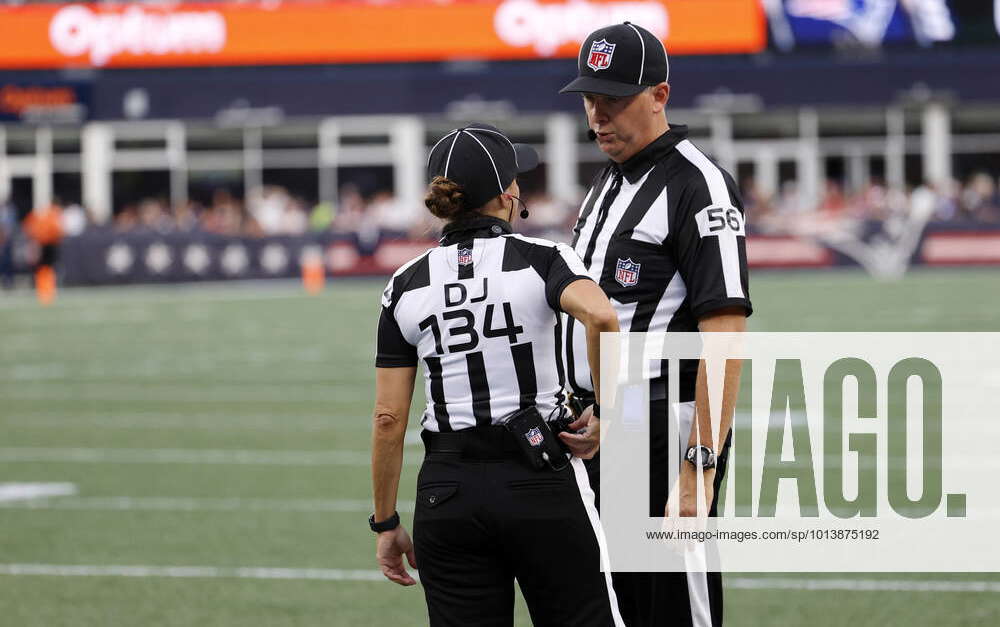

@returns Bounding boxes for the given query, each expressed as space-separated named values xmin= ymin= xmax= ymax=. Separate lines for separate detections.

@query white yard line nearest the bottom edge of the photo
xmin=0 ymin=564 xmax=1000 ymax=593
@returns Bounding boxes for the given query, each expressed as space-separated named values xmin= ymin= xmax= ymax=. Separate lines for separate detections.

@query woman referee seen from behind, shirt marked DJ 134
xmin=369 ymin=124 xmax=623 ymax=627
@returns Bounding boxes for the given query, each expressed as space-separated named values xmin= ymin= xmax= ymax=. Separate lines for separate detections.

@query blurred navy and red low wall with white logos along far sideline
xmin=60 ymin=230 xmax=1000 ymax=285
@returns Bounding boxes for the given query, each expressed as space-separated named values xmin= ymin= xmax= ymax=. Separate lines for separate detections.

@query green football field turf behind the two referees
xmin=0 ymin=270 xmax=1000 ymax=627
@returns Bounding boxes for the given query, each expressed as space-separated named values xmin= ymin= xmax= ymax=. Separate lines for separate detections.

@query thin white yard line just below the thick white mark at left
xmin=0 ymin=496 xmax=414 ymax=513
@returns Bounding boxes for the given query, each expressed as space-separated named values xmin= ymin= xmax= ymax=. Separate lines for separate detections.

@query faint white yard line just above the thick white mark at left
xmin=0 ymin=447 xmax=421 ymax=466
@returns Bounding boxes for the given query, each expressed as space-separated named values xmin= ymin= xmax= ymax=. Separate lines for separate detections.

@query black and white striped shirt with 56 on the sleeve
xmin=565 ymin=126 xmax=752 ymax=402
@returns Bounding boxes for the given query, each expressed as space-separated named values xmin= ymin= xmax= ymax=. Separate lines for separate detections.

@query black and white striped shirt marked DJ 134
xmin=375 ymin=217 xmax=589 ymax=431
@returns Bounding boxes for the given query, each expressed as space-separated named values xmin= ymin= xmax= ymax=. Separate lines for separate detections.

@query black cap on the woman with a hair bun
xmin=427 ymin=122 xmax=538 ymax=209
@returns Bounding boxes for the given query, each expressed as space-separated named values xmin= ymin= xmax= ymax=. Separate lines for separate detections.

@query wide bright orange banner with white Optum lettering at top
xmin=0 ymin=0 xmax=767 ymax=69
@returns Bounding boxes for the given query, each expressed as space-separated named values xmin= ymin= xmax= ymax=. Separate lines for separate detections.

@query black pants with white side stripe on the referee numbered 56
xmin=584 ymin=401 xmax=731 ymax=627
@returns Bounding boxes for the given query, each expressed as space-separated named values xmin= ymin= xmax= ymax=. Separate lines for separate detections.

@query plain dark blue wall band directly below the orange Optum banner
xmin=0 ymin=49 xmax=1000 ymax=119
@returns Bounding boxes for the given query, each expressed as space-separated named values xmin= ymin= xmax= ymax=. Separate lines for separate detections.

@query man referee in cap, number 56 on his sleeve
xmin=562 ymin=22 xmax=752 ymax=627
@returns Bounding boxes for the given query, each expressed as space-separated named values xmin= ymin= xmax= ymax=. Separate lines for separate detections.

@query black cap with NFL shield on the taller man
xmin=559 ymin=22 xmax=670 ymax=97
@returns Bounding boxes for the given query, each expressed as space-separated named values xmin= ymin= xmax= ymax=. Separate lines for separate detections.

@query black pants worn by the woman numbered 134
xmin=413 ymin=427 xmax=621 ymax=627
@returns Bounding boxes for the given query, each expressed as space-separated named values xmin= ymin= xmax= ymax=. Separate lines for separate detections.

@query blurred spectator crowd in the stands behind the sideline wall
xmin=0 ymin=173 xmax=1000 ymax=252
